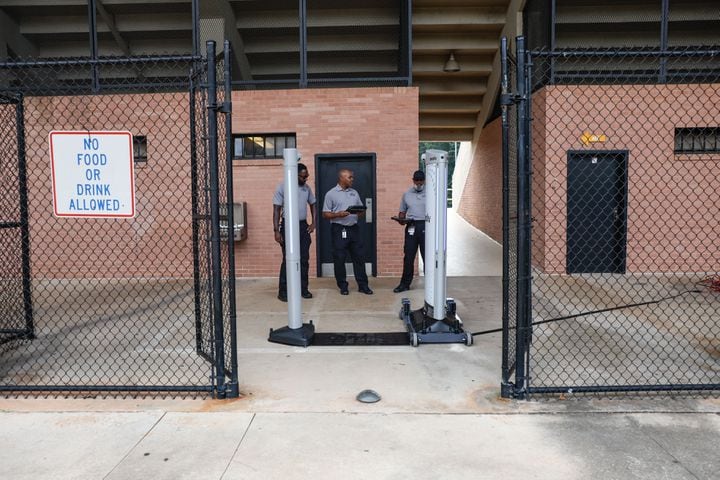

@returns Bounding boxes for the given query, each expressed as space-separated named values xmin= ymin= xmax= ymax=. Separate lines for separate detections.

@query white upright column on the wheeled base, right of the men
xmin=425 ymin=150 xmax=448 ymax=320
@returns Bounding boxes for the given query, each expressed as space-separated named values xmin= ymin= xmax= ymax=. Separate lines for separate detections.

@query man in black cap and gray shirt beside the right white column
xmin=393 ymin=170 xmax=425 ymax=293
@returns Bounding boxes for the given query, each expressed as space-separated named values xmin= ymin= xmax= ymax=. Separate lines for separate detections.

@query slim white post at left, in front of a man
xmin=283 ymin=148 xmax=302 ymax=330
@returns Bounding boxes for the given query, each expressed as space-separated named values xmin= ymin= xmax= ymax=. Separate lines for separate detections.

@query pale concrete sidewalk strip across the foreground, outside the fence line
xmin=0 ymin=401 xmax=720 ymax=480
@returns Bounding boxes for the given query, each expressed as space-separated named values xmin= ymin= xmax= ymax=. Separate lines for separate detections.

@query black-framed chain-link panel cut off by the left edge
xmin=0 ymin=96 xmax=34 ymax=343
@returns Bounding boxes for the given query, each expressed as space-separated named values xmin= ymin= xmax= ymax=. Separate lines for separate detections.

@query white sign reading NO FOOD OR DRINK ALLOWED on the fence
xmin=50 ymin=131 xmax=135 ymax=218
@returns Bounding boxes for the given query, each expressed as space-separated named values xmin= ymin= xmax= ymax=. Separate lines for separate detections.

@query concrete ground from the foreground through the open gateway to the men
xmin=0 ymin=209 xmax=720 ymax=480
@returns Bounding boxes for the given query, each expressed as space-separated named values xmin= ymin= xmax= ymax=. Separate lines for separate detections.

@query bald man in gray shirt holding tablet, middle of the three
xmin=323 ymin=168 xmax=373 ymax=295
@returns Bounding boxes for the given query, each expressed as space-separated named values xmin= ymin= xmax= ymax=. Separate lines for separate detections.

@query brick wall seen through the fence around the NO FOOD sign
xmin=22 ymin=93 xmax=193 ymax=278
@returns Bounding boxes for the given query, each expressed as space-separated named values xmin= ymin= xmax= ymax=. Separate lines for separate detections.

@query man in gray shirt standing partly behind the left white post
xmin=273 ymin=163 xmax=316 ymax=302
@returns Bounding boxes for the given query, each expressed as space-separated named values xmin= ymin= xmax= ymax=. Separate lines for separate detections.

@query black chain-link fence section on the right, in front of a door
xmin=501 ymin=37 xmax=720 ymax=398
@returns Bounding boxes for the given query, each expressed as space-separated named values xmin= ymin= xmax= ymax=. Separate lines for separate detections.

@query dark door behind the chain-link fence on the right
xmin=567 ymin=151 xmax=628 ymax=273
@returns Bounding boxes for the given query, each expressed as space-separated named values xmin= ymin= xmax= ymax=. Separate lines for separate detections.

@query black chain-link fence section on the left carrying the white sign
xmin=0 ymin=42 xmax=238 ymax=398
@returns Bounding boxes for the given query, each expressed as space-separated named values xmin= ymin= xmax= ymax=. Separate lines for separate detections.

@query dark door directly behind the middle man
xmin=315 ymin=153 xmax=377 ymax=277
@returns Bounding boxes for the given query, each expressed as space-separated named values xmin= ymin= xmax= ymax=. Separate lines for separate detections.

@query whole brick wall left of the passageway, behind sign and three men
xmin=16 ymin=87 xmax=418 ymax=278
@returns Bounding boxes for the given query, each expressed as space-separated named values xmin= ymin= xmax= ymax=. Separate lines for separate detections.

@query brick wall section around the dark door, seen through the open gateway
xmin=232 ymin=87 xmax=418 ymax=276
